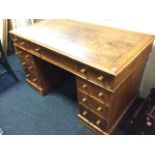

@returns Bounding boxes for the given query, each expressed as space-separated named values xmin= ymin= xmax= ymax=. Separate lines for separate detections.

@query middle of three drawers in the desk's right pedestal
xmin=78 ymin=91 xmax=110 ymax=119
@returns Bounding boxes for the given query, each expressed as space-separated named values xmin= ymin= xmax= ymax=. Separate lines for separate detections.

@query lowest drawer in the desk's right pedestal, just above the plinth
xmin=79 ymin=104 xmax=108 ymax=130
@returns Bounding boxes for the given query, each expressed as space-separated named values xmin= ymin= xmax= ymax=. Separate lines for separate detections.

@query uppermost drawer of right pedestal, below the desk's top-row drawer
xmin=77 ymin=78 xmax=110 ymax=105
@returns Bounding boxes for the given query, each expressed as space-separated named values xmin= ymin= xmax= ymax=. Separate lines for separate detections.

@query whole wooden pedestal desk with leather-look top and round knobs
xmin=11 ymin=20 xmax=154 ymax=134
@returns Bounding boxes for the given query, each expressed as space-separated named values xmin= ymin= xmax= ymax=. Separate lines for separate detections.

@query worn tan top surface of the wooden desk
xmin=11 ymin=19 xmax=154 ymax=76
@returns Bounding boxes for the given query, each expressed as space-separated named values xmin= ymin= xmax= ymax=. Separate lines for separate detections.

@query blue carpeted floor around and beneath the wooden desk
xmin=0 ymin=54 xmax=125 ymax=135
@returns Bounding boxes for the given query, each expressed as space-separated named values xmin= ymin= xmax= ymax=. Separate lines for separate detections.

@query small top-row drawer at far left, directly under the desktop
xmin=12 ymin=36 xmax=29 ymax=50
